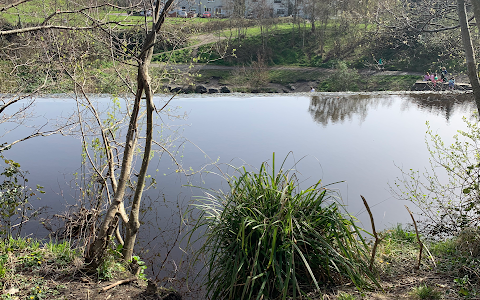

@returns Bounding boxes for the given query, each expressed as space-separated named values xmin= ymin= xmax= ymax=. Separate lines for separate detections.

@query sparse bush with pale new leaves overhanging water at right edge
xmin=392 ymin=116 xmax=480 ymax=236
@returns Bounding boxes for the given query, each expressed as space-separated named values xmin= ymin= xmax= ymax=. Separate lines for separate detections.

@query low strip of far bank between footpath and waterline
xmin=0 ymin=63 xmax=468 ymax=95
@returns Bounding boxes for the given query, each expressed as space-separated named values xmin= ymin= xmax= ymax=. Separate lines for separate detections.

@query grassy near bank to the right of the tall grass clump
xmin=331 ymin=225 xmax=480 ymax=300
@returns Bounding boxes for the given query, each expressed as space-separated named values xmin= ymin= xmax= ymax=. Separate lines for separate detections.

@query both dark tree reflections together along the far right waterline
xmin=308 ymin=93 xmax=475 ymax=126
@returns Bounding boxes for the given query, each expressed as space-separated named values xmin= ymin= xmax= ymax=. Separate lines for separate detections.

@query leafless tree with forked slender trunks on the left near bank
xmin=0 ymin=0 xmax=182 ymax=268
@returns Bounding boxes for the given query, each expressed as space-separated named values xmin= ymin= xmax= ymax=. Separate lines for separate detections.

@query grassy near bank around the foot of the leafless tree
xmin=0 ymin=238 xmax=183 ymax=300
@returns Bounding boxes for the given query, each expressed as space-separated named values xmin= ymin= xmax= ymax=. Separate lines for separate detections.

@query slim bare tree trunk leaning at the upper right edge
xmin=457 ymin=0 xmax=480 ymax=111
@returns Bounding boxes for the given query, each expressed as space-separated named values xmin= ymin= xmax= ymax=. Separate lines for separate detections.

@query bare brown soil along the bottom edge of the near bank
xmin=3 ymin=266 xmax=472 ymax=300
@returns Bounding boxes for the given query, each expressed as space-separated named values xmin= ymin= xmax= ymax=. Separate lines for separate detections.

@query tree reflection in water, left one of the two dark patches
xmin=308 ymin=95 xmax=392 ymax=126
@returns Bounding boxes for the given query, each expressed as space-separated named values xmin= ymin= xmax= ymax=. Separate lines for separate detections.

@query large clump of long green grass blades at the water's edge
xmin=195 ymin=158 xmax=376 ymax=299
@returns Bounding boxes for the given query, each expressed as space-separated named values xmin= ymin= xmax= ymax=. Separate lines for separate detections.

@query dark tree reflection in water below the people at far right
xmin=402 ymin=93 xmax=476 ymax=121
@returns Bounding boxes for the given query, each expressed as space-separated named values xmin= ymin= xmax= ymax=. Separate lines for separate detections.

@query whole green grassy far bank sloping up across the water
xmin=0 ymin=12 xmax=465 ymax=94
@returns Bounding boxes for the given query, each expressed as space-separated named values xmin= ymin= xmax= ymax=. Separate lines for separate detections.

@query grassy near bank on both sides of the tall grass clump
xmin=0 ymin=225 xmax=480 ymax=300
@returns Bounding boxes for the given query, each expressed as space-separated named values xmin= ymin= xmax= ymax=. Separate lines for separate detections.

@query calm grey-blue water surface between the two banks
xmin=3 ymin=94 xmax=474 ymax=276
